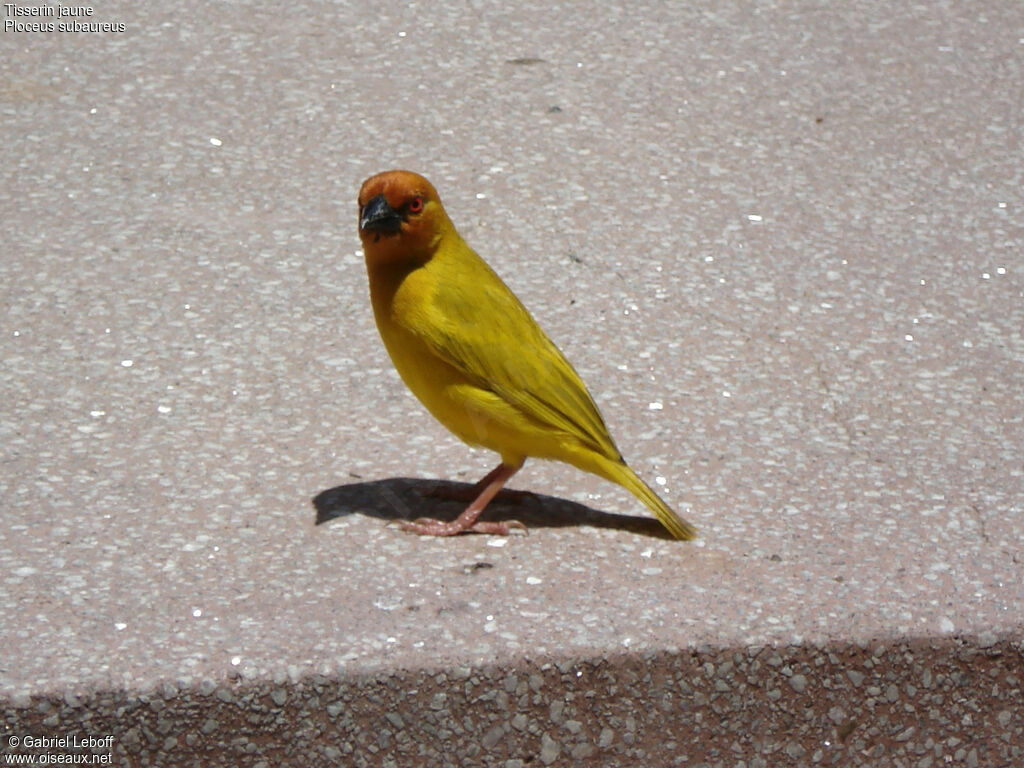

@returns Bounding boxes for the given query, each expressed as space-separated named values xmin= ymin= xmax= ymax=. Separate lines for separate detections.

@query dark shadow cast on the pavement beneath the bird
xmin=312 ymin=477 xmax=672 ymax=540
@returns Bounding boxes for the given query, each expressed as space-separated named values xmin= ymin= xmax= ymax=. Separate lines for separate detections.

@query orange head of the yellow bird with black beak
xmin=359 ymin=171 xmax=452 ymax=265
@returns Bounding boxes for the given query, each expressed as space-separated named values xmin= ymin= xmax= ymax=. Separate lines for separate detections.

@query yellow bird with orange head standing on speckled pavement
xmin=358 ymin=171 xmax=696 ymax=539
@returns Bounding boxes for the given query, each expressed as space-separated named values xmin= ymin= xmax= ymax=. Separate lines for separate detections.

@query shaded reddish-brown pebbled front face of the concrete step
xmin=8 ymin=640 xmax=1024 ymax=768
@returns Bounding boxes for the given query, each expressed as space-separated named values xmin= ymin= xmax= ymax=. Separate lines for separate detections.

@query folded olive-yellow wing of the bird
xmin=416 ymin=239 xmax=622 ymax=461
